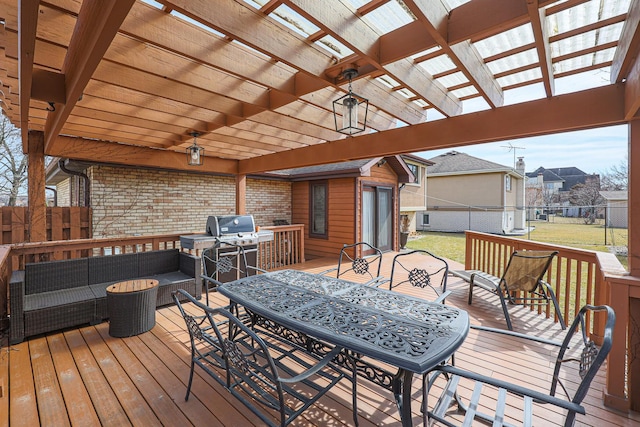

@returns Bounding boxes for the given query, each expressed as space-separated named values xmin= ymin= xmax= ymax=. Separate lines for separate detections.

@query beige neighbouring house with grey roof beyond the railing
xmin=422 ymin=151 xmax=525 ymax=234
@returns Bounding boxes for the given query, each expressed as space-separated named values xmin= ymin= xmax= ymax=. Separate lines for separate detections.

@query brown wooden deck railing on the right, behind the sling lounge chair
xmin=465 ymin=231 xmax=625 ymax=339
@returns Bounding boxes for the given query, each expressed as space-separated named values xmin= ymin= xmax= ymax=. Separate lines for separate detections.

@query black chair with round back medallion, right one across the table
xmin=389 ymin=249 xmax=451 ymax=303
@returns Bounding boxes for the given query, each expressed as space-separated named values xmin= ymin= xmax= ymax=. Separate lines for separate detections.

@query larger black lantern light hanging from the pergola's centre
xmin=333 ymin=68 xmax=369 ymax=135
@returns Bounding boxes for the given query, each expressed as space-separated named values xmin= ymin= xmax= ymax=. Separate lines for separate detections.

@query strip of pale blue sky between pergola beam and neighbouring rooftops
xmin=414 ymin=125 xmax=628 ymax=174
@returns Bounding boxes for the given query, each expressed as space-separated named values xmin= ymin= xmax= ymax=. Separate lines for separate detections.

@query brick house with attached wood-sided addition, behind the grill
xmin=47 ymin=156 xmax=413 ymax=259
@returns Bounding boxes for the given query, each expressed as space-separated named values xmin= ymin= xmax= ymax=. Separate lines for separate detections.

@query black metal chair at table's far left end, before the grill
xmin=200 ymin=240 xmax=264 ymax=305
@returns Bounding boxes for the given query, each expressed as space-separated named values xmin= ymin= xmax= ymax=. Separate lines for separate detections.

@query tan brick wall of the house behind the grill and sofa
xmin=87 ymin=166 xmax=291 ymax=237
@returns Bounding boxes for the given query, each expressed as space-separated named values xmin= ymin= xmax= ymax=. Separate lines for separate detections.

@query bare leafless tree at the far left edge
xmin=0 ymin=114 xmax=27 ymax=206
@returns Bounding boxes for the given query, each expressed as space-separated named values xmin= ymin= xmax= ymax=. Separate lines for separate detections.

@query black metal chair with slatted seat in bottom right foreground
xmin=423 ymin=305 xmax=615 ymax=426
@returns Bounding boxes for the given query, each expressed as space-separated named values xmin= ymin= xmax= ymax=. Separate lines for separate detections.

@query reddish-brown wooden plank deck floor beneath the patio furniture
xmin=0 ymin=254 xmax=640 ymax=427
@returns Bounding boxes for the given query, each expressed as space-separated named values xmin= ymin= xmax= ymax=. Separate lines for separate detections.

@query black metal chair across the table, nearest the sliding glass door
xmin=318 ymin=242 xmax=386 ymax=286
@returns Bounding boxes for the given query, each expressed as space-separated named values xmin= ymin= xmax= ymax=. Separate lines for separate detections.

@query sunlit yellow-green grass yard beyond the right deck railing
xmin=407 ymin=217 xmax=628 ymax=268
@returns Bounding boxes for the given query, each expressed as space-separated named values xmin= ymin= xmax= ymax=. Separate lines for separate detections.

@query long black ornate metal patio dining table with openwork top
xmin=218 ymin=270 xmax=469 ymax=426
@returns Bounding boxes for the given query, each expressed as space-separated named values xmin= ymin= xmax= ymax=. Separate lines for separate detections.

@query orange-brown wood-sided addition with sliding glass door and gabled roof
xmin=273 ymin=156 xmax=413 ymax=259
